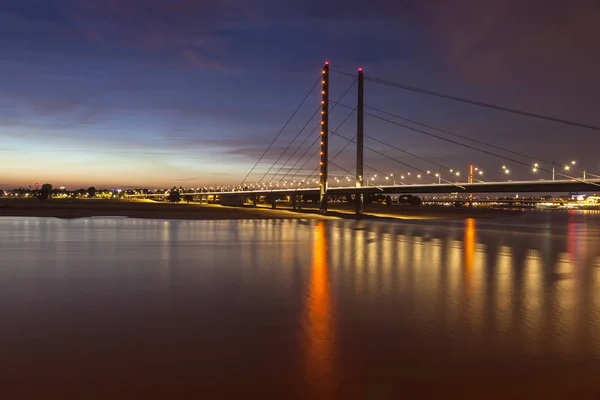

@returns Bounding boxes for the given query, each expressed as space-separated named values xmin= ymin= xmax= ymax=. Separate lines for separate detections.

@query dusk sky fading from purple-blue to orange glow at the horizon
xmin=0 ymin=0 xmax=600 ymax=188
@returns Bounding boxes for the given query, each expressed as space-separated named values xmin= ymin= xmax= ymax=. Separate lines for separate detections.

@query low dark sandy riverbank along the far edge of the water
xmin=0 ymin=198 xmax=523 ymax=220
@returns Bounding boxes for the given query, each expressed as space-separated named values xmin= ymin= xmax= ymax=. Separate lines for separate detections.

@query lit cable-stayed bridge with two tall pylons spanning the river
xmin=129 ymin=63 xmax=600 ymax=214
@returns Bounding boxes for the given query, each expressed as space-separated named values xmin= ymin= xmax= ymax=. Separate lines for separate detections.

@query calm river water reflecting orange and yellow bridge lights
xmin=0 ymin=212 xmax=600 ymax=399
